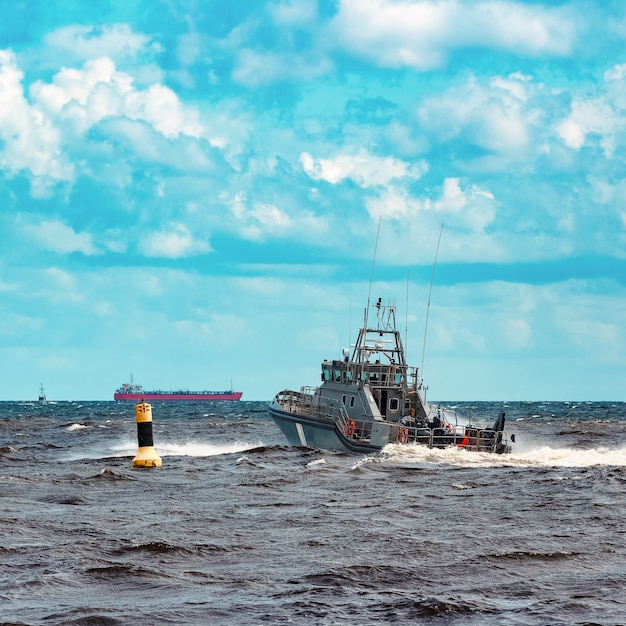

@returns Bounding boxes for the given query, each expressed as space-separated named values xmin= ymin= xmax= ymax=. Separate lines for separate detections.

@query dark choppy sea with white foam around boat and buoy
xmin=0 ymin=401 xmax=626 ymax=626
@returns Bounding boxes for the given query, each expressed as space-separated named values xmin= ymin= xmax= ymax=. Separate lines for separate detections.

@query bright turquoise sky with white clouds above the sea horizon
xmin=0 ymin=0 xmax=626 ymax=400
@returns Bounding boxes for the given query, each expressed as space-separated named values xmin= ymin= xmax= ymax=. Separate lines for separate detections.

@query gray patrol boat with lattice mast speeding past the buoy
xmin=269 ymin=298 xmax=515 ymax=454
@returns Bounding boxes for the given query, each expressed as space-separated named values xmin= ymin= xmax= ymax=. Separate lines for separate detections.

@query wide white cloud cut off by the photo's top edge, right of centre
xmin=331 ymin=0 xmax=576 ymax=70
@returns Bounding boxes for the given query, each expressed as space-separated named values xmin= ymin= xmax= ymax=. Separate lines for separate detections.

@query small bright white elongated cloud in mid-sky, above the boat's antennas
xmin=300 ymin=150 xmax=427 ymax=188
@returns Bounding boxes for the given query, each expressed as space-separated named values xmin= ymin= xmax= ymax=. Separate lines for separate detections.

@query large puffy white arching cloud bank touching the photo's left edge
xmin=0 ymin=50 xmax=211 ymax=196
